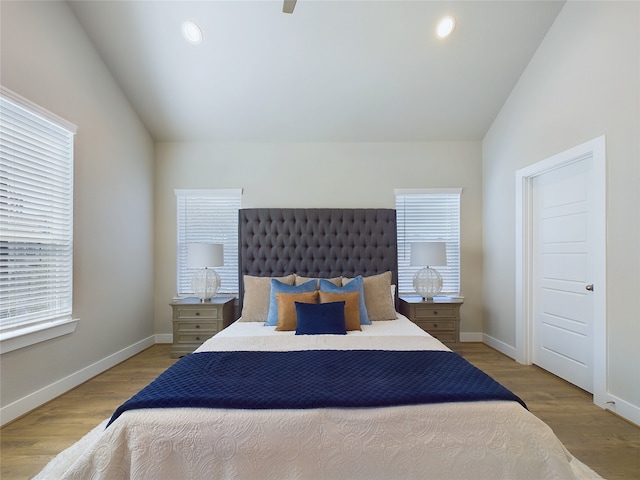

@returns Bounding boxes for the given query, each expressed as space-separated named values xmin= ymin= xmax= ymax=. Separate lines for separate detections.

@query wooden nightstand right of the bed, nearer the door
xmin=400 ymin=295 xmax=463 ymax=344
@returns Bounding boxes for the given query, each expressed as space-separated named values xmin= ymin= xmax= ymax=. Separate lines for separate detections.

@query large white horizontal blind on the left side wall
xmin=0 ymin=88 xmax=76 ymax=332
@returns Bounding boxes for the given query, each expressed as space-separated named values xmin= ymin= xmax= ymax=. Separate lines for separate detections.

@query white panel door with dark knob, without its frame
xmin=532 ymin=157 xmax=594 ymax=393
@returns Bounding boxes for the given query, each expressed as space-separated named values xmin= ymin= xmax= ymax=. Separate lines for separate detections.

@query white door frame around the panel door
xmin=515 ymin=135 xmax=607 ymax=406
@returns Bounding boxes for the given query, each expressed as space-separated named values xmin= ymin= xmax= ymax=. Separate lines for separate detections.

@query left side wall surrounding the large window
xmin=0 ymin=1 xmax=154 ymax=423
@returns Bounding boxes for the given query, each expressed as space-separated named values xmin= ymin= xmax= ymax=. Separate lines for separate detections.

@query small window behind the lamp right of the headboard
xmin=395 ymin=188 xmax=462 ymax=295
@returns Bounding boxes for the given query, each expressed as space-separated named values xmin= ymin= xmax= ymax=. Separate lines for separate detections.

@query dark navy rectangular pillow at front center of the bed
xmin=296 ymin=302 xmax=347 ymax=335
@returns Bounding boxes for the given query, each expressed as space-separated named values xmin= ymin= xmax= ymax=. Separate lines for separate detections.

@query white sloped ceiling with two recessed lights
xmin=69 ymin=0 xmax=563 ymax=142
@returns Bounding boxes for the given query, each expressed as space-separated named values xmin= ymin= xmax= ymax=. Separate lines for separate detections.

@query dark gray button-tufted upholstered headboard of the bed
xmin=238 ymin=208 xmax=398 ymax=308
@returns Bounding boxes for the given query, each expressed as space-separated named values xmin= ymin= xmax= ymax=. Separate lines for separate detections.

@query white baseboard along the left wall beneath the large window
xmin=0 ymin=336 xmax=155 ymax=426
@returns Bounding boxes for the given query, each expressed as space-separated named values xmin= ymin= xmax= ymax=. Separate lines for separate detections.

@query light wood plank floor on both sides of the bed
xmin=0 ymin=343 xmax=640 ymax=480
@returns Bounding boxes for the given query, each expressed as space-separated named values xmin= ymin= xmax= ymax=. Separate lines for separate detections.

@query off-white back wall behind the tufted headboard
xmin=155 ymin=142 xmax=482 ymax=340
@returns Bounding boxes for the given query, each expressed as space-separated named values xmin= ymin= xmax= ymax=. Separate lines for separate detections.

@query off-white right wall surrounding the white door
xmin=483 ymin=2 xmax=640 ymax=421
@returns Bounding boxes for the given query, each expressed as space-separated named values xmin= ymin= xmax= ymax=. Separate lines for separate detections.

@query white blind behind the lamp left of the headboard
xmin=175 ymin=188 xmax=242 ymax=295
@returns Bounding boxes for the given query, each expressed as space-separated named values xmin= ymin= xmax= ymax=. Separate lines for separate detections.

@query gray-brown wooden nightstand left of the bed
xmin=171 ymin=297 xmax=234 ymax=358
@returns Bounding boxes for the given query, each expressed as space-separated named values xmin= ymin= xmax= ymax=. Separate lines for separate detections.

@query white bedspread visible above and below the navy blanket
xmin=56 ymin=317 xmax=599 ymax=480
